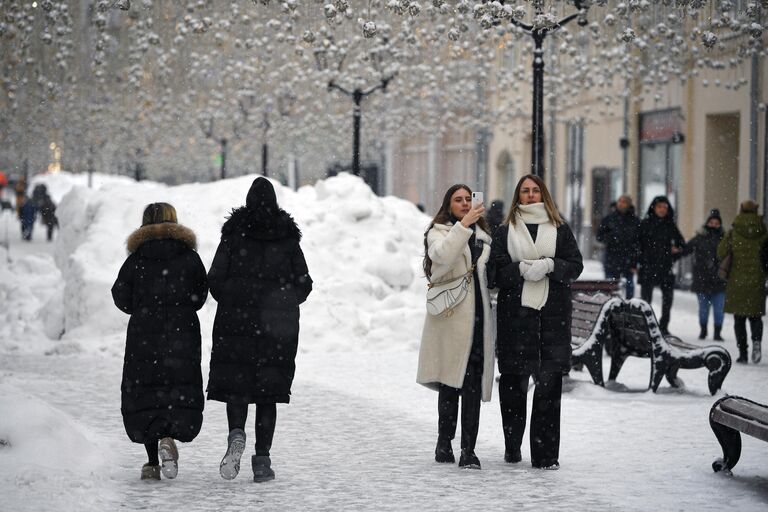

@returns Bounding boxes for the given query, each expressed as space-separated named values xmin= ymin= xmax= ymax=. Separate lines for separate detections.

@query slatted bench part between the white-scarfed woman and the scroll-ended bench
xmin=571 ymin=292 xmax=622 ymax=386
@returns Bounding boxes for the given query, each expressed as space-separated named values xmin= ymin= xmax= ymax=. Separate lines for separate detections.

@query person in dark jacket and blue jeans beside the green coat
xmin=683 ymin=208 xmax=725 ymax=341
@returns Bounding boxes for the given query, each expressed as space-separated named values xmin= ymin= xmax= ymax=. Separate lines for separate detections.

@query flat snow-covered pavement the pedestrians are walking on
xmin=0 ymin=346 xmax=768 ymax=510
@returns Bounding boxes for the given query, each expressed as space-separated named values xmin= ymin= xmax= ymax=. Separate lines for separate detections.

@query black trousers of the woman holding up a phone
xmin=437 ymin=362 xmax=483 ymax=452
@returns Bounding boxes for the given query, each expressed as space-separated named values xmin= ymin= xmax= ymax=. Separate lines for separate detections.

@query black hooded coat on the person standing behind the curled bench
xmin=637 ymin=196 xmax=685 ymax=285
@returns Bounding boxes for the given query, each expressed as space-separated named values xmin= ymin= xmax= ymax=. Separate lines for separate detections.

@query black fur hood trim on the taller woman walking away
xmin=221 ymin=206 xmax=301 ymax=241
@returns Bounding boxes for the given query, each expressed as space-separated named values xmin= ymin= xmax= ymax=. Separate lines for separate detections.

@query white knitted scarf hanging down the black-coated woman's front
xmin=507 ymin=203 xmax=557 ymax=310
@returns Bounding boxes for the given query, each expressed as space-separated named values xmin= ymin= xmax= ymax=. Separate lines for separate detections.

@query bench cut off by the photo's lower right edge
xmin=709 ymin=396 xmax=768 ymax=473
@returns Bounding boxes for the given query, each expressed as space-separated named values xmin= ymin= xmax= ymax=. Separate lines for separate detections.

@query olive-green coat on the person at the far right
xmin=717 ymin=213 xmax=768 ymax=316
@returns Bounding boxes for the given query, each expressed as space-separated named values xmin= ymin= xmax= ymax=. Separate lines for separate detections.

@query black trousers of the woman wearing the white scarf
xmin=499 ymin=373 xmax=563 ymax=466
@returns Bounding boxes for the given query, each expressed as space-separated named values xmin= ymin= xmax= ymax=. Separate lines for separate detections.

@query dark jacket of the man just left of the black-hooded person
xmin=597 ymin=208 xmax=640 ymax=274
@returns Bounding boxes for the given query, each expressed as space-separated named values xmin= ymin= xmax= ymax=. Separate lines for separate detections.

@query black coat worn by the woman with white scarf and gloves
xmin=488 ymin=224 xmax=584 ymax=375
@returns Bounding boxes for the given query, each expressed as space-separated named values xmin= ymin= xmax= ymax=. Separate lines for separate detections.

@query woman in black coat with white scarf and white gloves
xmin=488 ymin=175 xmax=584 ymax=469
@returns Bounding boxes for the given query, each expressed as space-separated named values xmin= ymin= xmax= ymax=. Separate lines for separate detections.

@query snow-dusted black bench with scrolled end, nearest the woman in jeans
xmin=605 ymin=299 xmax=731 ymax=395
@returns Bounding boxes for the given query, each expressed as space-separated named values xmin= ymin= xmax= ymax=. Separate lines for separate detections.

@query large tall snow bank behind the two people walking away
xmin=37 ymin=175 xmax=429 ymax=350
